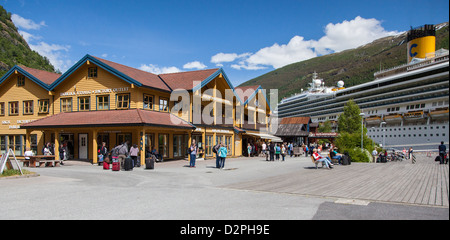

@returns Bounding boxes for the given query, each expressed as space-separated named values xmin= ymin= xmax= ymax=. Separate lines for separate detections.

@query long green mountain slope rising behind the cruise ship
xmin=240 ymin=22 xmax=449 ymax=100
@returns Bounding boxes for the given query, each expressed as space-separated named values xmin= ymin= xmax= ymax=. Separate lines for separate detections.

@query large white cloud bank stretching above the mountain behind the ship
xmin=211 ymin=16 xmax=399 ymax=70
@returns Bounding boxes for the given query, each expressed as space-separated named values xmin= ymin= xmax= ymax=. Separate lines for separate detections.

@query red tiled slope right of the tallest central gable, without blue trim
xmin=93 ymin=56 xmax=171 ymax=91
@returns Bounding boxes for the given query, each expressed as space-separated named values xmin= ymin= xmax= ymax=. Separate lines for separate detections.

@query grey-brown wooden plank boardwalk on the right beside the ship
xmin=225 ymin=154 xmax=449 ymax=208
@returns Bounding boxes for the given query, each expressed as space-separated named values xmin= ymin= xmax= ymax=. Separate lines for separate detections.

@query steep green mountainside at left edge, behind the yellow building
xmin=0 ymin=6 xmax=55 ymax=77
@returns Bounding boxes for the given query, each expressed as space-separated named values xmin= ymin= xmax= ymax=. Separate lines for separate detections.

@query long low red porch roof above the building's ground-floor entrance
xmin=20 ymin=109 xmax=195 ymax=129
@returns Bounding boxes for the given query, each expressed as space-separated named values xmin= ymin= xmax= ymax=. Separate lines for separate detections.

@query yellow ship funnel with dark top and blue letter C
xmin=407 ymin=25 xmax=436 ymax=63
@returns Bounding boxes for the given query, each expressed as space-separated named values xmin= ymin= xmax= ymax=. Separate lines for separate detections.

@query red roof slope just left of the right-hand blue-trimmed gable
xmin=159 ymin=68 xmax=219 ymax=90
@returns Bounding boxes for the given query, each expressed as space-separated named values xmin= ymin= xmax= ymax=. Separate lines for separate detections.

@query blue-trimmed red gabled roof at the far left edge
xmin=0 ymin=65 xmax=61 ymax=90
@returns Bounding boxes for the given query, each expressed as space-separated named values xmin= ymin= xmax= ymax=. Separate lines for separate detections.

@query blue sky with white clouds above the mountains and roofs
xmin=0 ymin=0 xmax=449 ymax=86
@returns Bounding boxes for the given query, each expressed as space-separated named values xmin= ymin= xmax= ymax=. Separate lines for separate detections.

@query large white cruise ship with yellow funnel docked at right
xmin=278 ymin=25 xmax=449 ymax=150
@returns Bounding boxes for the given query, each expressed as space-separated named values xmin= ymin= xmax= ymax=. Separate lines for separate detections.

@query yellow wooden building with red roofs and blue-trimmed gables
xmin=0 ymin=55 xmax=270 ymax=163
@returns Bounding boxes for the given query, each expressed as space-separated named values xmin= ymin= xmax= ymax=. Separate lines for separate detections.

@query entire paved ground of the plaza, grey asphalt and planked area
xmin=0 ymin=154 xmax=449 ymax=220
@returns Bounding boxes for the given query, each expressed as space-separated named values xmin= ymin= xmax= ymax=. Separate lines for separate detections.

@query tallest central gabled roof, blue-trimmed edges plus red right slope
xmin=50 ymin=54 xmax=171 ymax=92
